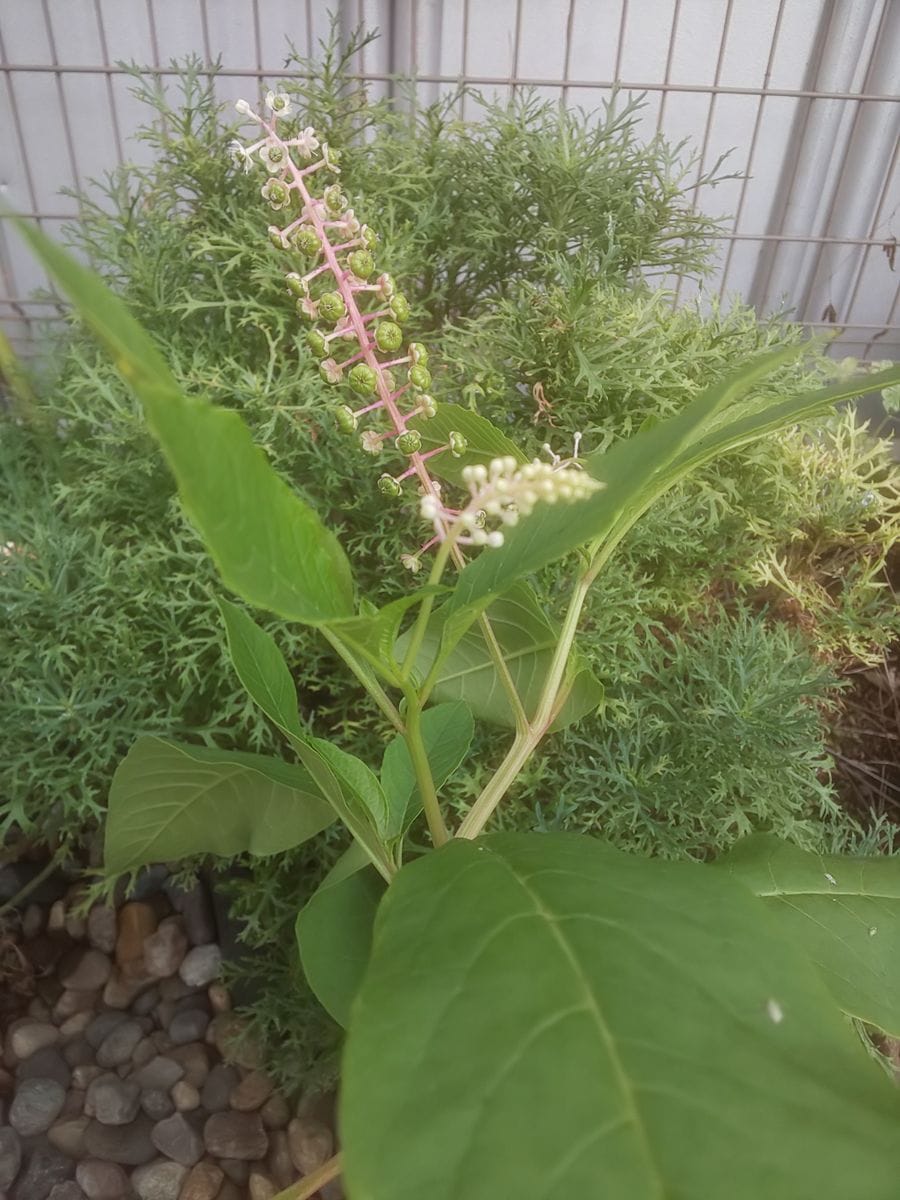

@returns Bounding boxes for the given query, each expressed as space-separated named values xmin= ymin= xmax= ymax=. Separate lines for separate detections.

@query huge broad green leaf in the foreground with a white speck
xmin=341 ymin=834 xmax=900 ymax=1200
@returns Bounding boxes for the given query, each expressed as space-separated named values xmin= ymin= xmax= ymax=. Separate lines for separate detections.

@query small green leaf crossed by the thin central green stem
xmin=382 ymin=701 xmax=475 ymax=838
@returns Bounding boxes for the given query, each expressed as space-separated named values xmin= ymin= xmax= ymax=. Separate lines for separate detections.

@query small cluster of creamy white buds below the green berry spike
xmin=420 ymin=456 xmax=604 ymax=547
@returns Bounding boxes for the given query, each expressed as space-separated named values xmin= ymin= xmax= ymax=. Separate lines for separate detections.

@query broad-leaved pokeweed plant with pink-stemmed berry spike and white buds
xmin=20 ymin=92 xmax=900 ymax=1200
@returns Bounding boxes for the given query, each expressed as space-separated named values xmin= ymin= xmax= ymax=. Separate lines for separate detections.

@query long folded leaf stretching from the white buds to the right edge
xmin=451 ymin=347 xmax=900 ymax=607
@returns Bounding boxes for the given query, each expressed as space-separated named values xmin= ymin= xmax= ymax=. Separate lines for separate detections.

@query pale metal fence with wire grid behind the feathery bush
xmin=0 ymin=0 xmax=900 ymax=358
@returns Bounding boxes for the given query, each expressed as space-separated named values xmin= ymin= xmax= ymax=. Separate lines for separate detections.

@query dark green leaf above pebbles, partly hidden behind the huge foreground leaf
xmin=296 ymin=865 xmax=385 ymax=1028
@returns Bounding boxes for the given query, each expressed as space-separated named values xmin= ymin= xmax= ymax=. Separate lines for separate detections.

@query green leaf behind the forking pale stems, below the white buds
xmin=401 ymin=582 xmax=604 ymax=730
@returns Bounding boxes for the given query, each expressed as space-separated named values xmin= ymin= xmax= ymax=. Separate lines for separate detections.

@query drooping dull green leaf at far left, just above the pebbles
xmin=104 ymin=737 xmax=335 ymax=875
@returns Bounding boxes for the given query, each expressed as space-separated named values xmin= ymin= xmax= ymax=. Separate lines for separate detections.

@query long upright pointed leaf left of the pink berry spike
xmin=17 ymin=222 xmax=353 ymax=625
